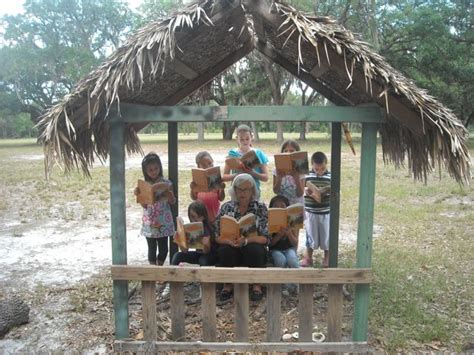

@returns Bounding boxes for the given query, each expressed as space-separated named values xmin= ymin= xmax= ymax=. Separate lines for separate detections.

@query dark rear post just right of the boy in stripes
xmin=329 ymin=122 xmax=341 ymax=267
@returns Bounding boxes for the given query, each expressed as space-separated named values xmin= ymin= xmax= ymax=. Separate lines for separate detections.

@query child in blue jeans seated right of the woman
xmin=270 ymin=195 xmax=300 ymax=293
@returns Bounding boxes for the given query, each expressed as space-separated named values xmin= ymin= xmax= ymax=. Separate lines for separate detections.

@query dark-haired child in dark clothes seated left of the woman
xmin=171 ymin=200 xmax=217 ymax=266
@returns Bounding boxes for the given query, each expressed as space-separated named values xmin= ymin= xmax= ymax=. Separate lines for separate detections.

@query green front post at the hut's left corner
xmin=110 ymin=121 xmax=129 ymax=339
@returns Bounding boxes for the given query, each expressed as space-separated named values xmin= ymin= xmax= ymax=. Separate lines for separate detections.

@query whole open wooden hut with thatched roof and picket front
xmin=39 ymin=0 xmax=470 ymax=351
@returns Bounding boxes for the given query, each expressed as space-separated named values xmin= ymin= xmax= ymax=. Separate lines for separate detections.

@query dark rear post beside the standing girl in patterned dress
xmin=168 ymin=122 xmax=179 ymax=264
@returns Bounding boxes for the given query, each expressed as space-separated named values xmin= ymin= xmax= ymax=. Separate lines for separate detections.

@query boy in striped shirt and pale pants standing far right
xmin=301 ymin=152 xmax=331 ymax=267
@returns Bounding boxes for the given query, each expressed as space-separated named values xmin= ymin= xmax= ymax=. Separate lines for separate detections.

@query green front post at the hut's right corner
xmin=352 ymin=123 xmax=377 ymax=341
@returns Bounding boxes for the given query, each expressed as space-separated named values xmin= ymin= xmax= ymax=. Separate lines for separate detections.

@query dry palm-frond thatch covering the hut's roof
xmin=38 ymin=0 xmax=470 ymax=182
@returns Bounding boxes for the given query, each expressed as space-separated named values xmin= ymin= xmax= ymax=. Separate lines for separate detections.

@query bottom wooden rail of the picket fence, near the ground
xmin=114 ymin=340 xmax=368 ymax=353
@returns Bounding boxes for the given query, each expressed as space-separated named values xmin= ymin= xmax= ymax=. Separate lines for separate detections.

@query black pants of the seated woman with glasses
xmin=217 ymin=243 xmax=267 ymax=267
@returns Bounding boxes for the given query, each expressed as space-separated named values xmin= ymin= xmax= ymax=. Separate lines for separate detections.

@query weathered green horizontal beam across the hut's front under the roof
xmin=112 ymin=103 xmax=384 ymax=123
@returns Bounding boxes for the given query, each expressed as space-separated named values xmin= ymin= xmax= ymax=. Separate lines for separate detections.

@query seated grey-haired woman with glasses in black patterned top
xmin=216 ymin=174 xmax=269 ymax=301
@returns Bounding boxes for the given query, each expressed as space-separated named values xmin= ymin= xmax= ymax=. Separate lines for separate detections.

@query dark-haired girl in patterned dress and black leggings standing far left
xmin=134 ymin=152 xmax=176 ymax=265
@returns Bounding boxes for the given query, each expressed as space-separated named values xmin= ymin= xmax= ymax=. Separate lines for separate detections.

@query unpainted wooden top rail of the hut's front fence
xmin=112 ymin=265 xmax=372 ymax=284
